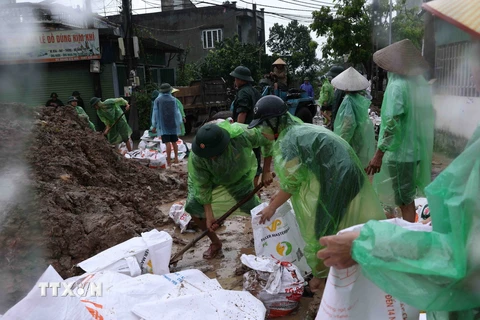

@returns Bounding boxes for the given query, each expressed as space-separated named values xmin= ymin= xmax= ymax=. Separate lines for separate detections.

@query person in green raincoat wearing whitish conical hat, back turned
xmin=332 ymin=67 xmax=375 ymax=168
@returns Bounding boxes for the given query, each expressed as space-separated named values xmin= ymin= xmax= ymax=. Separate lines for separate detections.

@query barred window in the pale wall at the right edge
xmin=435 ymin=41 xmax=479 ymax=97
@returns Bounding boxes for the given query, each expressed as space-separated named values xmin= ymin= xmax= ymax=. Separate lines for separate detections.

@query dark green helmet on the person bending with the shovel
xmin=192 ymin=123 xmax=230 ymax=158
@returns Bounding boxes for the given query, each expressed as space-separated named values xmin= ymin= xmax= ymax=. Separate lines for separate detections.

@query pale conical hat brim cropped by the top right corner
xmin=423 ymin=0 xmax=480 ymax=38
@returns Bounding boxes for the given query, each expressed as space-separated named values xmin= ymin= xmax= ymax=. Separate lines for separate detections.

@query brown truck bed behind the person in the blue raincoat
xmin=175 ymin=78 xmax=233 ymax=134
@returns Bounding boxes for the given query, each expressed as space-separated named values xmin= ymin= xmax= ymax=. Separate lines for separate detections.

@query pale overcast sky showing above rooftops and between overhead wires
xmin=17 ymin=0 xmax=333 ymax=58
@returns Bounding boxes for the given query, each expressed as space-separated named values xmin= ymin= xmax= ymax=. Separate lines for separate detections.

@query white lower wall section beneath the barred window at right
xmin=433 ymin=95 xmax=480 ymax=156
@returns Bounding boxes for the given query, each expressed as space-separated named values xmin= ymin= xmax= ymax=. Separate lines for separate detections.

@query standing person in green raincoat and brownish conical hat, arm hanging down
xmin=367 ymin=39 xmax=434 ymax=222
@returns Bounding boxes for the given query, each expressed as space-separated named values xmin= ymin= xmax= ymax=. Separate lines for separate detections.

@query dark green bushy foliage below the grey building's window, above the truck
xmin=200 ymin=36 xmax=266 ymax=84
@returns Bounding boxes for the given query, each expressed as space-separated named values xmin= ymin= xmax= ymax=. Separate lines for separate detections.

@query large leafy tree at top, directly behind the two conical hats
xmin=310 ymin=0 xmax=424 ymax=72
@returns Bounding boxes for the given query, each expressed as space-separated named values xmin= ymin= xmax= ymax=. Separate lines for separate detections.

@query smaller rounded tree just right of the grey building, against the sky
xmin=268 ymin=20 xmax=318 ymax=77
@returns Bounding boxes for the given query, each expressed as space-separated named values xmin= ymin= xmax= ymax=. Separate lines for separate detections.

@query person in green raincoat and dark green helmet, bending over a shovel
xmin=185 ymin=120 xmax=272 ymax=259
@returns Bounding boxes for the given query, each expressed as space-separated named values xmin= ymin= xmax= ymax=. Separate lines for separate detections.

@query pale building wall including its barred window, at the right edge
xmin=424 ymin=13 xmax=480 ymax=155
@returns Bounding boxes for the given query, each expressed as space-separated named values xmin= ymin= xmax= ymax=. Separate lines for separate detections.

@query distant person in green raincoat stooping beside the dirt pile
xmin=90 ymin=97 xmax=133 ymax=151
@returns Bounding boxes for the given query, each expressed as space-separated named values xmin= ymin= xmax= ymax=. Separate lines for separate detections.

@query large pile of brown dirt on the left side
xmin=0 ymin=104 xmax=187 ymax=313
